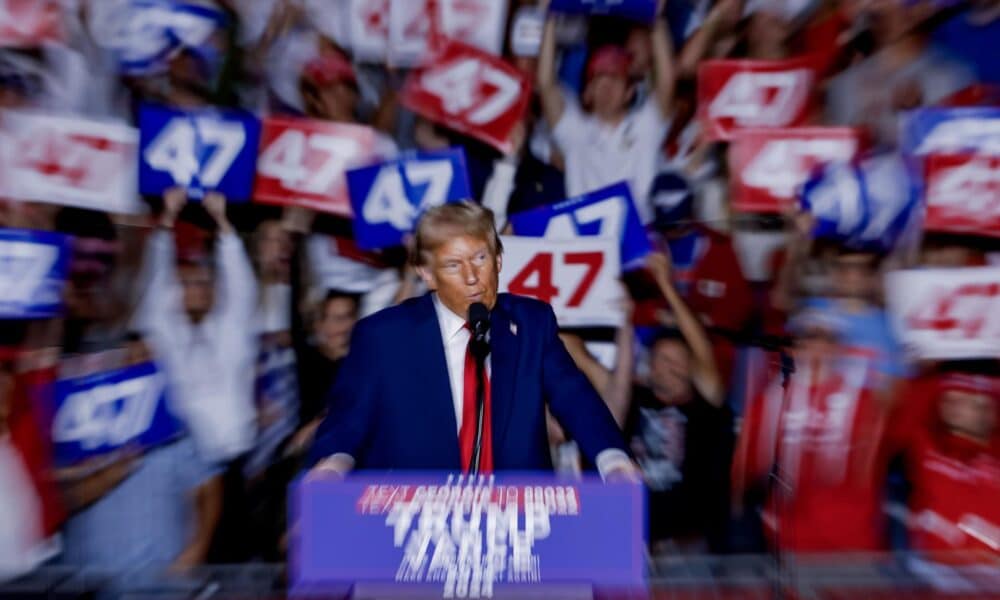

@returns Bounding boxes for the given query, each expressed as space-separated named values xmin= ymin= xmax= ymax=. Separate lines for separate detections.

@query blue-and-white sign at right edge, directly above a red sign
xmin=900 ymin=107 xmax=1000 ymax=156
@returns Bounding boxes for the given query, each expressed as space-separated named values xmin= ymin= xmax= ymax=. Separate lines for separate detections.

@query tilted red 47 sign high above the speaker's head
xmin=402 ymin=41 xmax=531 ymax=152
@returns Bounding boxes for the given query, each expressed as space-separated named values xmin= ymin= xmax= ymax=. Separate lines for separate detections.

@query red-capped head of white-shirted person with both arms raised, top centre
xmin=582 ymin=44 xmax=634 ymax=121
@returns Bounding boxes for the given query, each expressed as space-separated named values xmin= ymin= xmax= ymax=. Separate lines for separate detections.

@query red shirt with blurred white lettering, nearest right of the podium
xmin=733 ymin=357 xmax=885 ymax=552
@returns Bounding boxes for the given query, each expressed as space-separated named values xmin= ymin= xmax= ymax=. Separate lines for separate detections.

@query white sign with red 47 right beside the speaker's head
xmin=500 ymin=236 xmax=625 ymax=327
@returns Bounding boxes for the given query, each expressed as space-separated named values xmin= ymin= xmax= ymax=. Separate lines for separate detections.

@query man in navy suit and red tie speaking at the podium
xmin=310 ymin=203 xmax=636 ymax=478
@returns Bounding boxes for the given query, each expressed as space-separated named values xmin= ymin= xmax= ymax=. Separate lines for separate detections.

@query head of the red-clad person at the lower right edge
xmin=938 ymin=373 xmax=1000 ymax=444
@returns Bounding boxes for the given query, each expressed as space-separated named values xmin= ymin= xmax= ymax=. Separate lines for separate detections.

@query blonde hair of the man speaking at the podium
xmin=410 ymin=202 xmax=503 ymax=266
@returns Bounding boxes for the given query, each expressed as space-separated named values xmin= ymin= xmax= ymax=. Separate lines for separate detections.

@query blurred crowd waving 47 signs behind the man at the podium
xmin=0 ymin=0 xmax=1000 ymax=597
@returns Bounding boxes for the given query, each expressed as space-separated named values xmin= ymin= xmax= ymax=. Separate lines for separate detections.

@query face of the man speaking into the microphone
xmin=417 ymin=235 xmax=503 ymax=317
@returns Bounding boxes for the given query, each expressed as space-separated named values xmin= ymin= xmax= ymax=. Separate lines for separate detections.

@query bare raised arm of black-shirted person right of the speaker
xmin=647 ymin=252 xmax=724 ymax=407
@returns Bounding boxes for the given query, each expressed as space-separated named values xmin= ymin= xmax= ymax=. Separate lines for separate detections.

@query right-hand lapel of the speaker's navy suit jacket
xmin=490 ymin=304 xmax=520 ymax=457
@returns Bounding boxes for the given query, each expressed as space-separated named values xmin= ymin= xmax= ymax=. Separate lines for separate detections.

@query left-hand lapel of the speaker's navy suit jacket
xmin=411 ymin=294 xmax=461 ymax=465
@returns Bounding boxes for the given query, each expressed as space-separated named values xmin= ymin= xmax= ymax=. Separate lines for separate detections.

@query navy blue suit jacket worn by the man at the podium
xmin=310 ymin=294 xmax=625 ymax=471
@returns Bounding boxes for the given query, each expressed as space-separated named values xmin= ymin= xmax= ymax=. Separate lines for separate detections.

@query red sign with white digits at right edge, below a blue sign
xmin=924 ymin=154 xmax=1000 ymax=237
